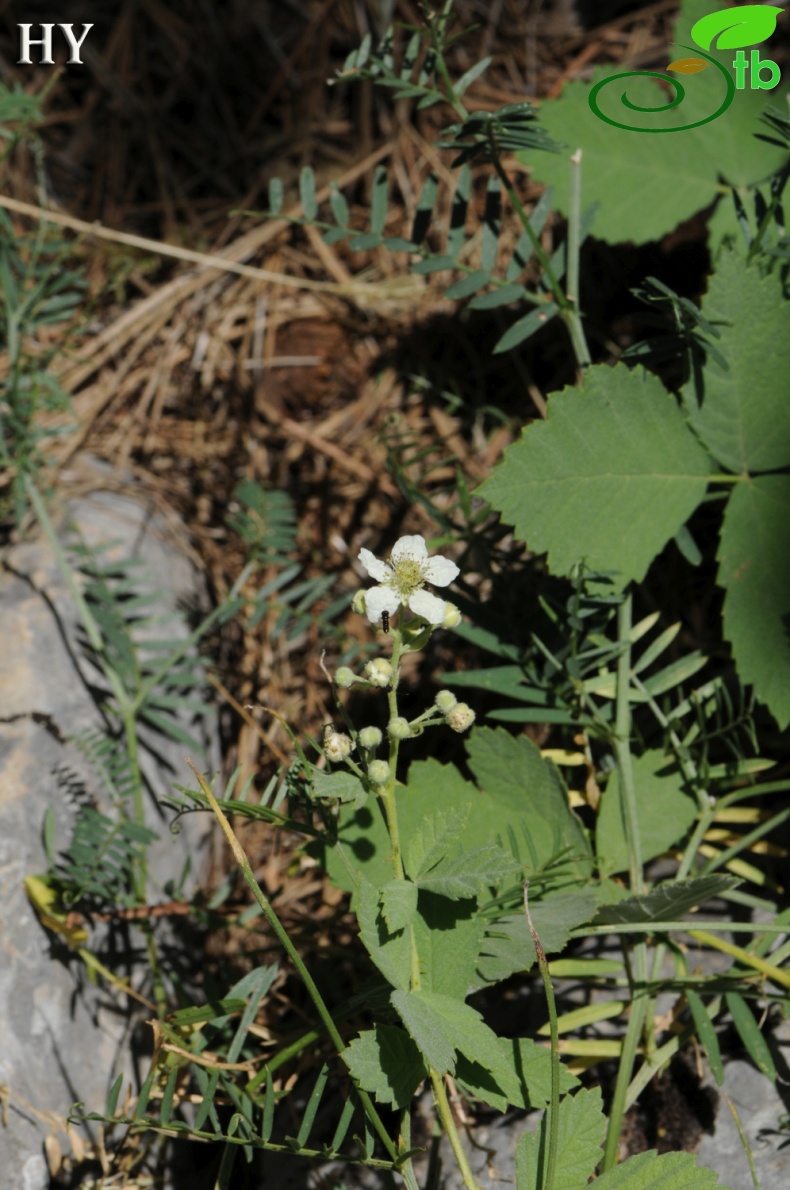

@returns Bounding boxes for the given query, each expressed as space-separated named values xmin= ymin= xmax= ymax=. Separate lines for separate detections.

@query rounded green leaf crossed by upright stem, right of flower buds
xmin=595 ymin=751 xmax=696 ymax=876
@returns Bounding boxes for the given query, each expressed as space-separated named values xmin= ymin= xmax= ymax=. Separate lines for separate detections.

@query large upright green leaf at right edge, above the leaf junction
xmin=684 ymin=252 xmax=790 ymax=472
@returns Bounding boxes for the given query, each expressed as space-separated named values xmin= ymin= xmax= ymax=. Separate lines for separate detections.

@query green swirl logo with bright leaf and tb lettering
xmin=588 ymin=4 xmax=782 ymax=133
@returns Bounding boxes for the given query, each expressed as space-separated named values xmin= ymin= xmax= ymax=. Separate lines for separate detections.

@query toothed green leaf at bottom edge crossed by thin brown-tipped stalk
xmin=515 ymin=1086 xmax=607 ymax=1190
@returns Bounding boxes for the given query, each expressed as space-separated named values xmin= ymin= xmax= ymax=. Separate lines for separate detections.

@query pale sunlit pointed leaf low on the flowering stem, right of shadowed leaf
xmin=390 ymin=989 xmax=521 ymax=1102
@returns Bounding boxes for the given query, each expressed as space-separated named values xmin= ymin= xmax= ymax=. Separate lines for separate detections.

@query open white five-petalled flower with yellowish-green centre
xmin=359 ymin=533 xmax=459 ymax=625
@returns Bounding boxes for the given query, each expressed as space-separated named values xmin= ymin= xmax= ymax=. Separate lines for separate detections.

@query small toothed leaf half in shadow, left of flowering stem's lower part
xmin=344 ymin=1025 xmax=427 ymax=1108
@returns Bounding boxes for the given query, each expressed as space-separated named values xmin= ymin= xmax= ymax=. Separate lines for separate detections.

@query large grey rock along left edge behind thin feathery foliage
xmin=0 ymin=471 xmax=218 ymax=1190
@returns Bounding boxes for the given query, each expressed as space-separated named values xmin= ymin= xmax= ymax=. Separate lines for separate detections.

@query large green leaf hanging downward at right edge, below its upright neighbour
xmin=719 ymin=473 xmax=790 ymax=729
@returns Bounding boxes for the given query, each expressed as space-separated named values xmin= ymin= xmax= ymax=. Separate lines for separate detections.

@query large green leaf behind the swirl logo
xmin=528 ymin=0 xmax=788 ymax=244
